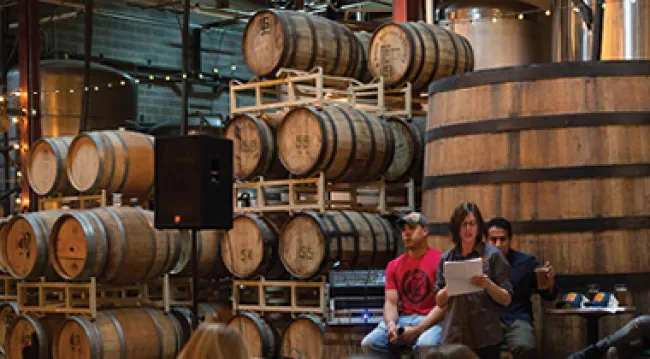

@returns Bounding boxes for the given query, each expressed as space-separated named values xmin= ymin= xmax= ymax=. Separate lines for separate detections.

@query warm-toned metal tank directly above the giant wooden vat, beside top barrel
xmin=438 ymin=0 xmax=551 ymax=70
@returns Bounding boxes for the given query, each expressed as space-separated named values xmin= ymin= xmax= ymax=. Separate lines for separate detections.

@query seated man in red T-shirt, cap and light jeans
xmin=361 ymin=212 xmax=444 ymax=358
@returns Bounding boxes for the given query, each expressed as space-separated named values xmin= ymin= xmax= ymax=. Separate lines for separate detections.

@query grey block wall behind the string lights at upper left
xmin=41 ymin=3 xmax=252 ymax=128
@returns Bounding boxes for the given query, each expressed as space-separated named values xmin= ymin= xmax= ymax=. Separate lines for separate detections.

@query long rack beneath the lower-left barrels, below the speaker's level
xmin=16 ymin=275 xmax=218 ymax=319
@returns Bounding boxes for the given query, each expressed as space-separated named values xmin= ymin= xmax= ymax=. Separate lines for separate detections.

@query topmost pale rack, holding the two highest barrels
xmin=230 ymin=67 xmax=426 ymax=118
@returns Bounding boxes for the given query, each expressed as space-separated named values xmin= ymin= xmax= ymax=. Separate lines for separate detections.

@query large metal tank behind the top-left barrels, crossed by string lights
xmin=7 ymin=60 xmax=138 ymax=137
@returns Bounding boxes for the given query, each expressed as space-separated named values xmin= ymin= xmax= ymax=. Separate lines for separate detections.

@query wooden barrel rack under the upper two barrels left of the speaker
xmin=38 ymin=190 xmax=149 ymax=211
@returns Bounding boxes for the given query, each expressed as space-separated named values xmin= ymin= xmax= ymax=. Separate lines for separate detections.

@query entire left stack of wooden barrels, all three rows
xmin=0 ymin=131 xmax=232 ymax=359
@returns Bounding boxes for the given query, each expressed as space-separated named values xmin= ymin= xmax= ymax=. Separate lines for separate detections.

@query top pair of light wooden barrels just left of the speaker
xmin=27 ymin=131 xmax=154 ymax=202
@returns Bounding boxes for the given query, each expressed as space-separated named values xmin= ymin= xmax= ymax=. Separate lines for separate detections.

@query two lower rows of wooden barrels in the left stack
xmin=0 ymin=207 xmax=231 ymax=359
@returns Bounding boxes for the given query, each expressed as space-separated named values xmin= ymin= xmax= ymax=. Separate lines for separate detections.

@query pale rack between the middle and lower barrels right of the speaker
xmin=233 ymin=172 xmax=415 ymax=214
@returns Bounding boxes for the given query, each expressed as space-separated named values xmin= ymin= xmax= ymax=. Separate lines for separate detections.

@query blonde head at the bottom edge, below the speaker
xmin=177 ymin=320 xmax=249 ymax=359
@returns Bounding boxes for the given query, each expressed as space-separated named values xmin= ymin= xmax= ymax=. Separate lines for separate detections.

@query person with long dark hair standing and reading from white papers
xmin=434 ymin=202 xmax=512 ymax=359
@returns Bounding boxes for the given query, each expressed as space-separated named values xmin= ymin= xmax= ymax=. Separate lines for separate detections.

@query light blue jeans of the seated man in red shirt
xmin=361 ymin=315 xmax=442 ymax=357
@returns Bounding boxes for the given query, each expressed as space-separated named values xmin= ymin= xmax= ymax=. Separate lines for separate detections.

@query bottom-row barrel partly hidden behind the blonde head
xmin=228 ymin=312 xmax=280 ymax=359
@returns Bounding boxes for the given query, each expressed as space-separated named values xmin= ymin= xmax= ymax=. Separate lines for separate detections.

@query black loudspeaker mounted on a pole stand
xmin=154 ymin=134 xmax=233 ymax=230
